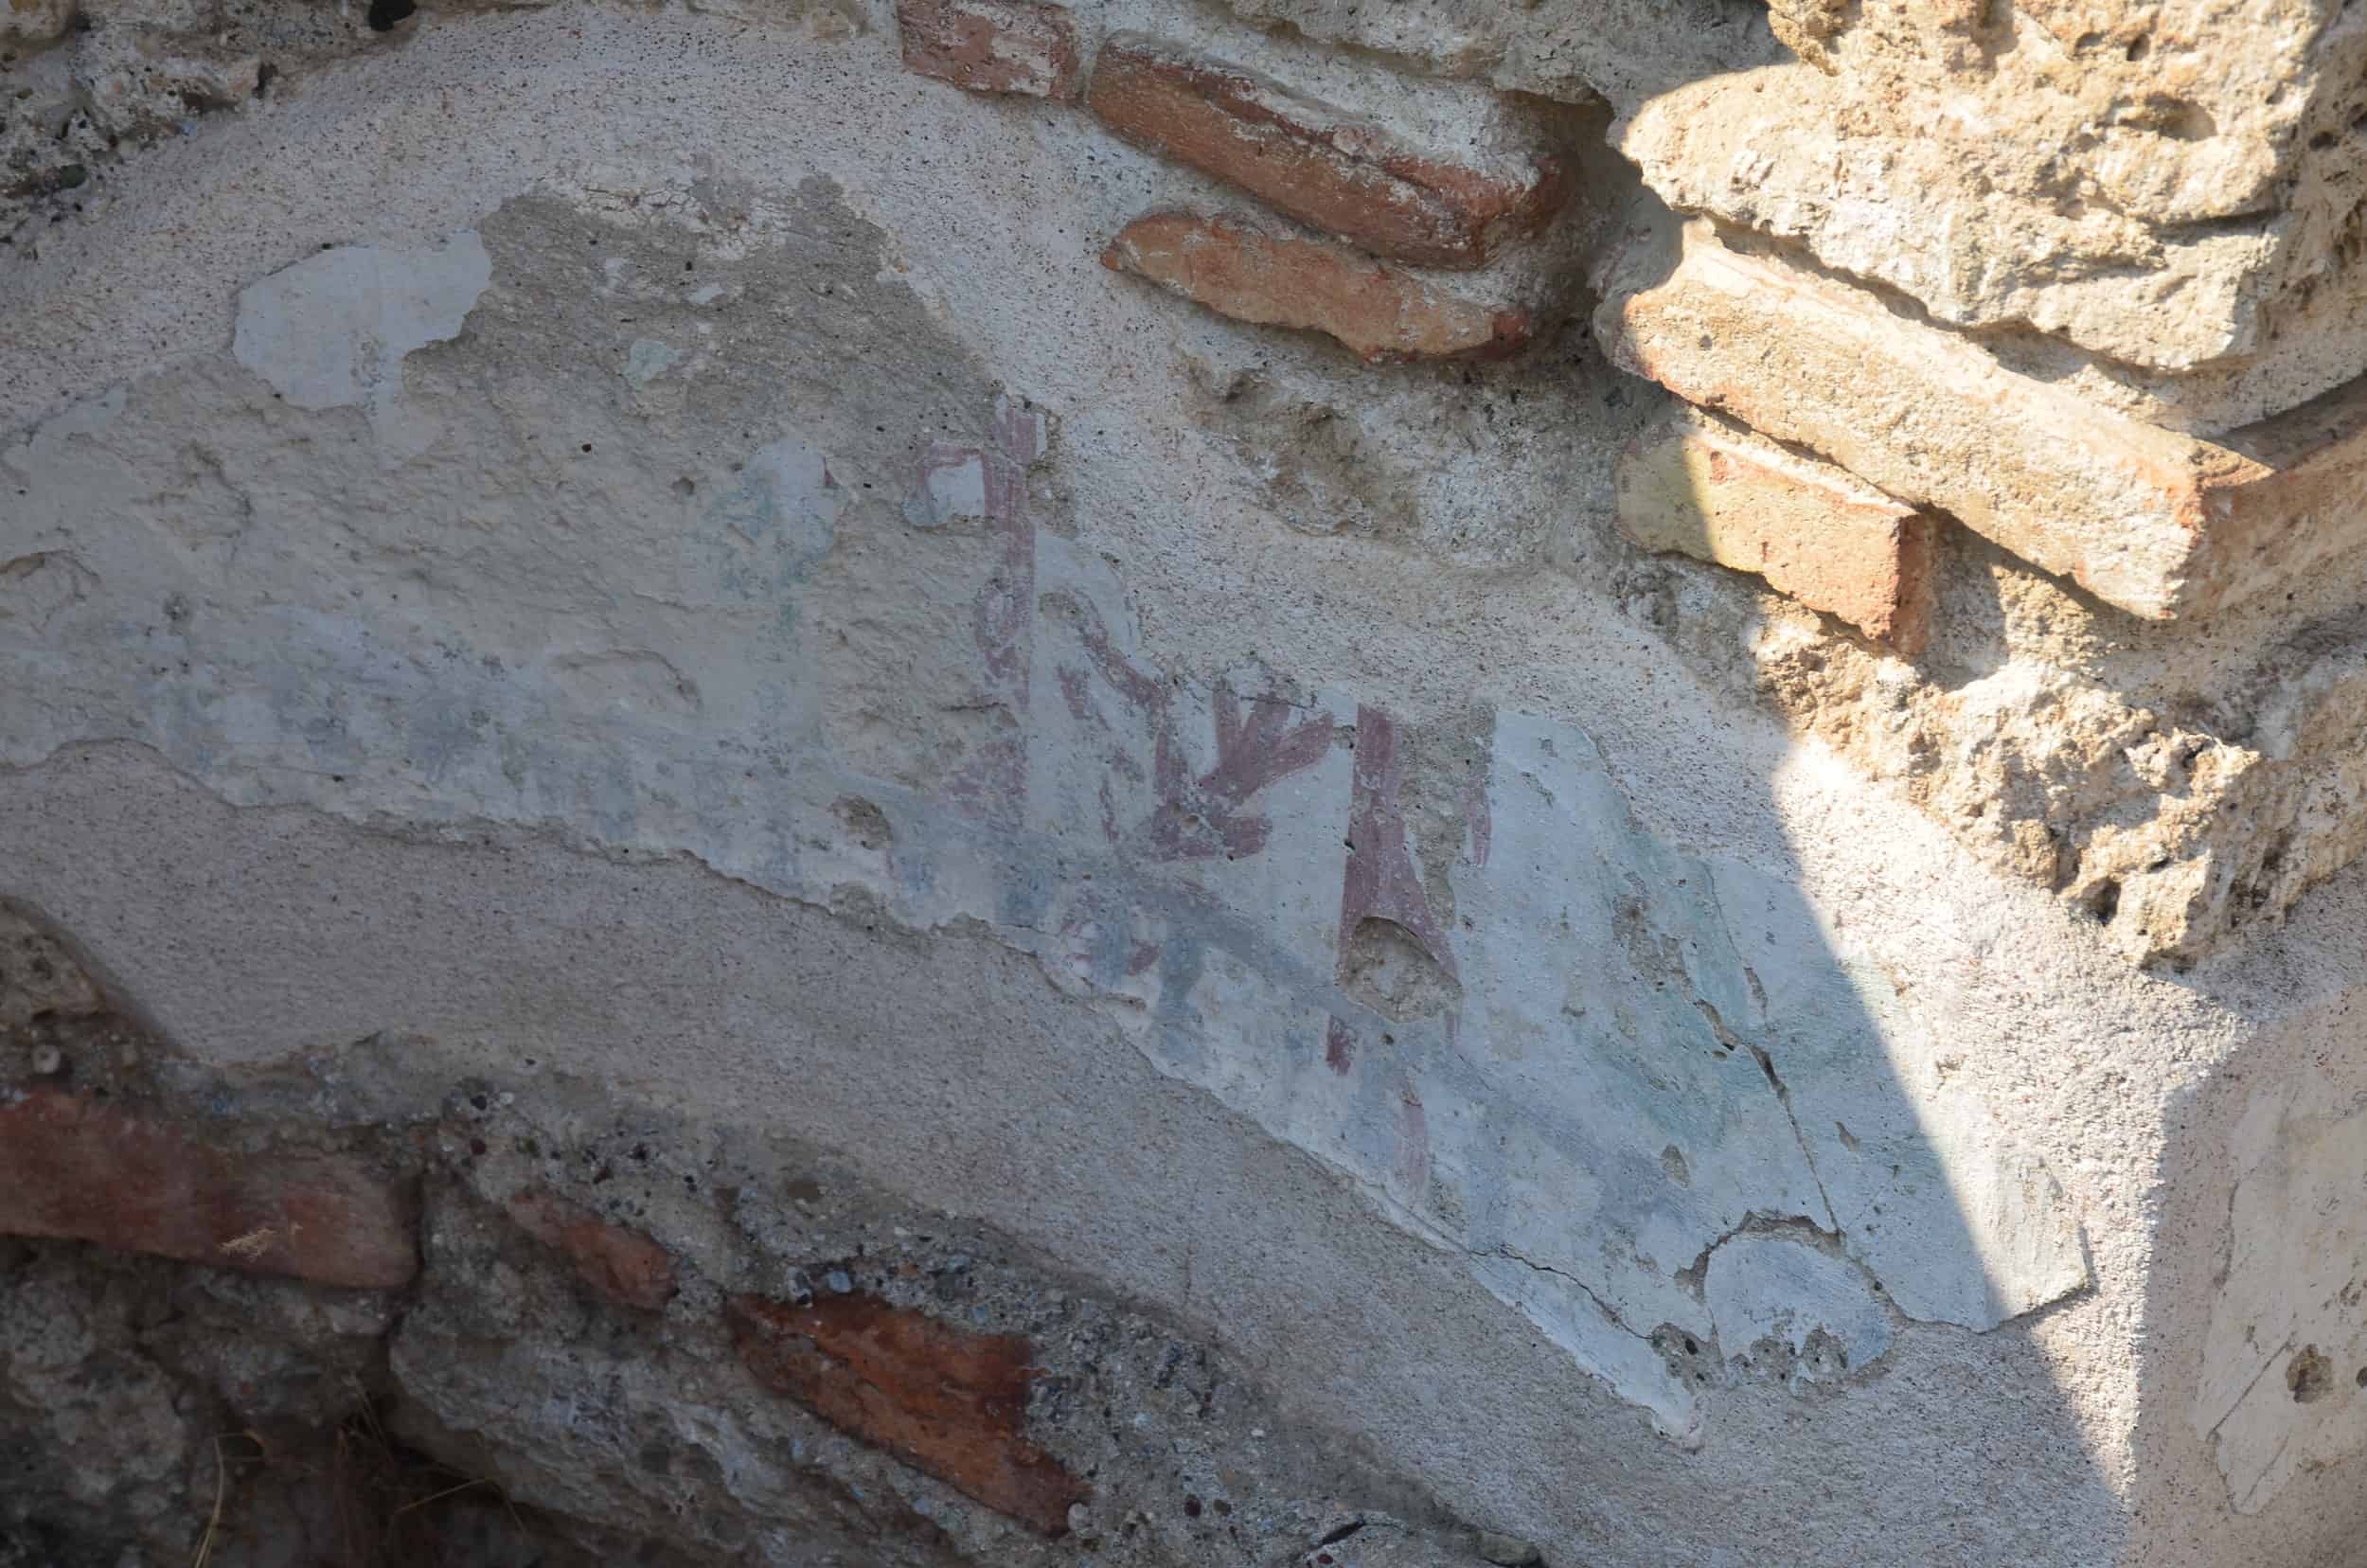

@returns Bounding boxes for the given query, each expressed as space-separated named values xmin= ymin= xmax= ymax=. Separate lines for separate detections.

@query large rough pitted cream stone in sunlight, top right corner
xmin=1622 ymin=0 xmax=2367 ymax=381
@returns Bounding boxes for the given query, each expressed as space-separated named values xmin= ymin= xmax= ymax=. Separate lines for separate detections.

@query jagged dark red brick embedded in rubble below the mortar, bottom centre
xmin=729 ymin=1293 xmax=1087 ymax=1535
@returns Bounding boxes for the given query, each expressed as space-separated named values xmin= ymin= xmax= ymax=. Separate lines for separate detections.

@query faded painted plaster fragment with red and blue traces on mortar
xmin=8 ymin=196 xmax=2088 ymax=1440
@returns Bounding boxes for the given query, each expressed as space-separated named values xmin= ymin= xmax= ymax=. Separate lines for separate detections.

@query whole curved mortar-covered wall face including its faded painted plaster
xmin=8 ymin=12 xmax=2353 ymax=1560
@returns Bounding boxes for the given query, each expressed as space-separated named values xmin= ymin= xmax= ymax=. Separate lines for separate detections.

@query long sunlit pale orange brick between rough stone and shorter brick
xmin=1595 ymin=223 xmax=2367 ymax=620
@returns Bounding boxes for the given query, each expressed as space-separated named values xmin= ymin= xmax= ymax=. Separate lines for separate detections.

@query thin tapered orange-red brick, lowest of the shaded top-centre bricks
xmin=1101 ymin=213 xmax=1532 ymax=360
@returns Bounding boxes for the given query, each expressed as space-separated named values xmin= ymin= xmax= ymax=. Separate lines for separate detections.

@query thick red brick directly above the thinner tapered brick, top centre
xmin=1087 ymin=33 xmax=1570 ymax=268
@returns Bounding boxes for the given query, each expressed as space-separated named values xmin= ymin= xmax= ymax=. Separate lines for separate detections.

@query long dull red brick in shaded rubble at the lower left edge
xmin=0 ymin=1090 xmax=419 ymax=1289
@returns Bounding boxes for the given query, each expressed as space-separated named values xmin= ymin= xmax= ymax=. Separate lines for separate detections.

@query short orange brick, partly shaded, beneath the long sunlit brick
xmin=1619 ymin=412 xmax=1931 ymax=653
